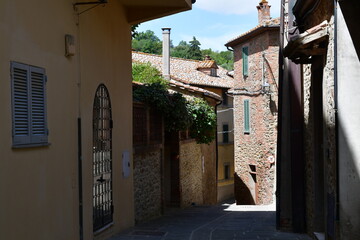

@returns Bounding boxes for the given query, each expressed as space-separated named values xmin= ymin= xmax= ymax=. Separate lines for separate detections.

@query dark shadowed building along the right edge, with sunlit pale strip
xmin=277 ymin=0 xmax=360 ymax=240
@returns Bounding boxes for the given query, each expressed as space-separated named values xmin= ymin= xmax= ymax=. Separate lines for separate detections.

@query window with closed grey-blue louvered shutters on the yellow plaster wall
xmin=11 ymin=62 xmax=48 ymax=147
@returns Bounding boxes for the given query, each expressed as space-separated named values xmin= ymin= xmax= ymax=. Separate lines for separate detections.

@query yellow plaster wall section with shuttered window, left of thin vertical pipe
xmin=0 ymin=0 xmax=78 ymax=240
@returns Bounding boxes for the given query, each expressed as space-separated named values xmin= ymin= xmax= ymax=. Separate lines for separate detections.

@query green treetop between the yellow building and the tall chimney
xmin=132 ymin=30 xmax=162 ymax=54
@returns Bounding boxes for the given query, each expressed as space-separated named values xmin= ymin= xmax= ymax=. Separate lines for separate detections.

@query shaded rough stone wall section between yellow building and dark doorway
xmin=134 ymin=149 xmax=162 ymax=223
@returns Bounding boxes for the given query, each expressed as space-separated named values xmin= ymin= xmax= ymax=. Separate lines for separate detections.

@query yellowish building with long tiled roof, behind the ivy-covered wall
xmin=132 ymin=47 xmax=234 ymax=202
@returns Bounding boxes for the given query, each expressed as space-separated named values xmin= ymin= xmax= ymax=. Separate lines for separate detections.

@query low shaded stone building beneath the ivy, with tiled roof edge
xmin=133 ymin=79 xmax=221 ymax=223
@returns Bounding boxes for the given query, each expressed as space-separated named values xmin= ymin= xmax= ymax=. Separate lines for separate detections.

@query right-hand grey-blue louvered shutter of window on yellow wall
xmin=30 ymin=67 xmax=47 ymax=143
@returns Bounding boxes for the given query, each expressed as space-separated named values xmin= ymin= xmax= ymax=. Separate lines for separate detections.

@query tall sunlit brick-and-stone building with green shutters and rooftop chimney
xmin=226 ymin=1 xmax=279 ymax=204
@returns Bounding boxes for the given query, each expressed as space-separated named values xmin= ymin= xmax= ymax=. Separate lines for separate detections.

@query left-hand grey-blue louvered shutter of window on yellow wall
xmin=11 ymin=62 xmax=30 ymax=145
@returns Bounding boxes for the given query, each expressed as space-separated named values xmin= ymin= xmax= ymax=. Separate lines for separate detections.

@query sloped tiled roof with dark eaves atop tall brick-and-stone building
xmin=225 ymin=18 xmax=280 ymax=47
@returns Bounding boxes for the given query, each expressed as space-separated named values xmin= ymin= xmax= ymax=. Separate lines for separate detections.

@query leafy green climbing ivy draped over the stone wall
xmin=133 ymin=64 xmax=216 ymax=144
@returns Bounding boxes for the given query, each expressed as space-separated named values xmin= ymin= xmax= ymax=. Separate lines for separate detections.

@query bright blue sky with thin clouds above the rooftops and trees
xmin=137 ymin=0 xmax=280 ymax=51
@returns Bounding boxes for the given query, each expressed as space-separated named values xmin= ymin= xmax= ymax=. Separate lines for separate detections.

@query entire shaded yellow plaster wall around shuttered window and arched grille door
xmin=0 ymin=0 xmax=134 ymax=240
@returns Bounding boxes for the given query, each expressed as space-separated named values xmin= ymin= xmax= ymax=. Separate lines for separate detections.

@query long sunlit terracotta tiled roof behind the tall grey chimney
xmin=132 ymin=52 xmax=234 ymax=88
